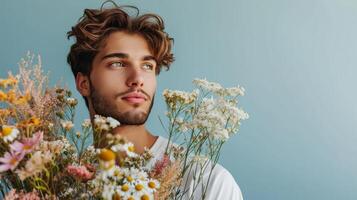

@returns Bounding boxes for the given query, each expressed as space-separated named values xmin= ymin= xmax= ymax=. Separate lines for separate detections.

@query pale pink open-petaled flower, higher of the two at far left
xmin=10 ymin=131 xmax=43 ymax=154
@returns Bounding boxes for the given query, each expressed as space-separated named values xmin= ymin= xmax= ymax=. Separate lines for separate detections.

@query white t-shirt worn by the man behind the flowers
xmin=148 ymin=136 xmax=243 ymax=200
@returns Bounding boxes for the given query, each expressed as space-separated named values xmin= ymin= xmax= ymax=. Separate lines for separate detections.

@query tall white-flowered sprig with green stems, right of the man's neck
xmin=163 ymin=79 xmax=249 ymax=199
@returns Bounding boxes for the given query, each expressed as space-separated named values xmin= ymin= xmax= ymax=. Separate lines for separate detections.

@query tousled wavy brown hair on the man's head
xmin=67 ymin=0 xmax=174 ymax=106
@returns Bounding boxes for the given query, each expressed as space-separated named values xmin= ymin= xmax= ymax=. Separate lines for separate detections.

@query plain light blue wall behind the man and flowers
xmin=0 ymin=0 xmax=357 ymax=200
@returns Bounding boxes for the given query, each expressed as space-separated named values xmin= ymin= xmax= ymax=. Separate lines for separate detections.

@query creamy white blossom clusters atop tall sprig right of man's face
xmin=163 ymin=79 xmax=249 ymax=141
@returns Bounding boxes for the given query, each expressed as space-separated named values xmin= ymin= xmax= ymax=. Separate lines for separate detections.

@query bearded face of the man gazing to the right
xmin=88 ymin=32 xmax=157 ymax=125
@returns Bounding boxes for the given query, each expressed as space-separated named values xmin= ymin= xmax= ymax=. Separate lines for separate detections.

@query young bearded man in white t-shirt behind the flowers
xmin=67 ymin=2 xmax=242 ymax=200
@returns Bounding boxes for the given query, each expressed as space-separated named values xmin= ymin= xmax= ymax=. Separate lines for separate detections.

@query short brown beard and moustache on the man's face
xmin=89 ymin=79 xmax=155 ymax=125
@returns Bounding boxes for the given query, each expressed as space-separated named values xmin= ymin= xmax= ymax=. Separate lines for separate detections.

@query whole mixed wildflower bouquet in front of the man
xmin=0 ymin=54 xmax=248 ymax=200
